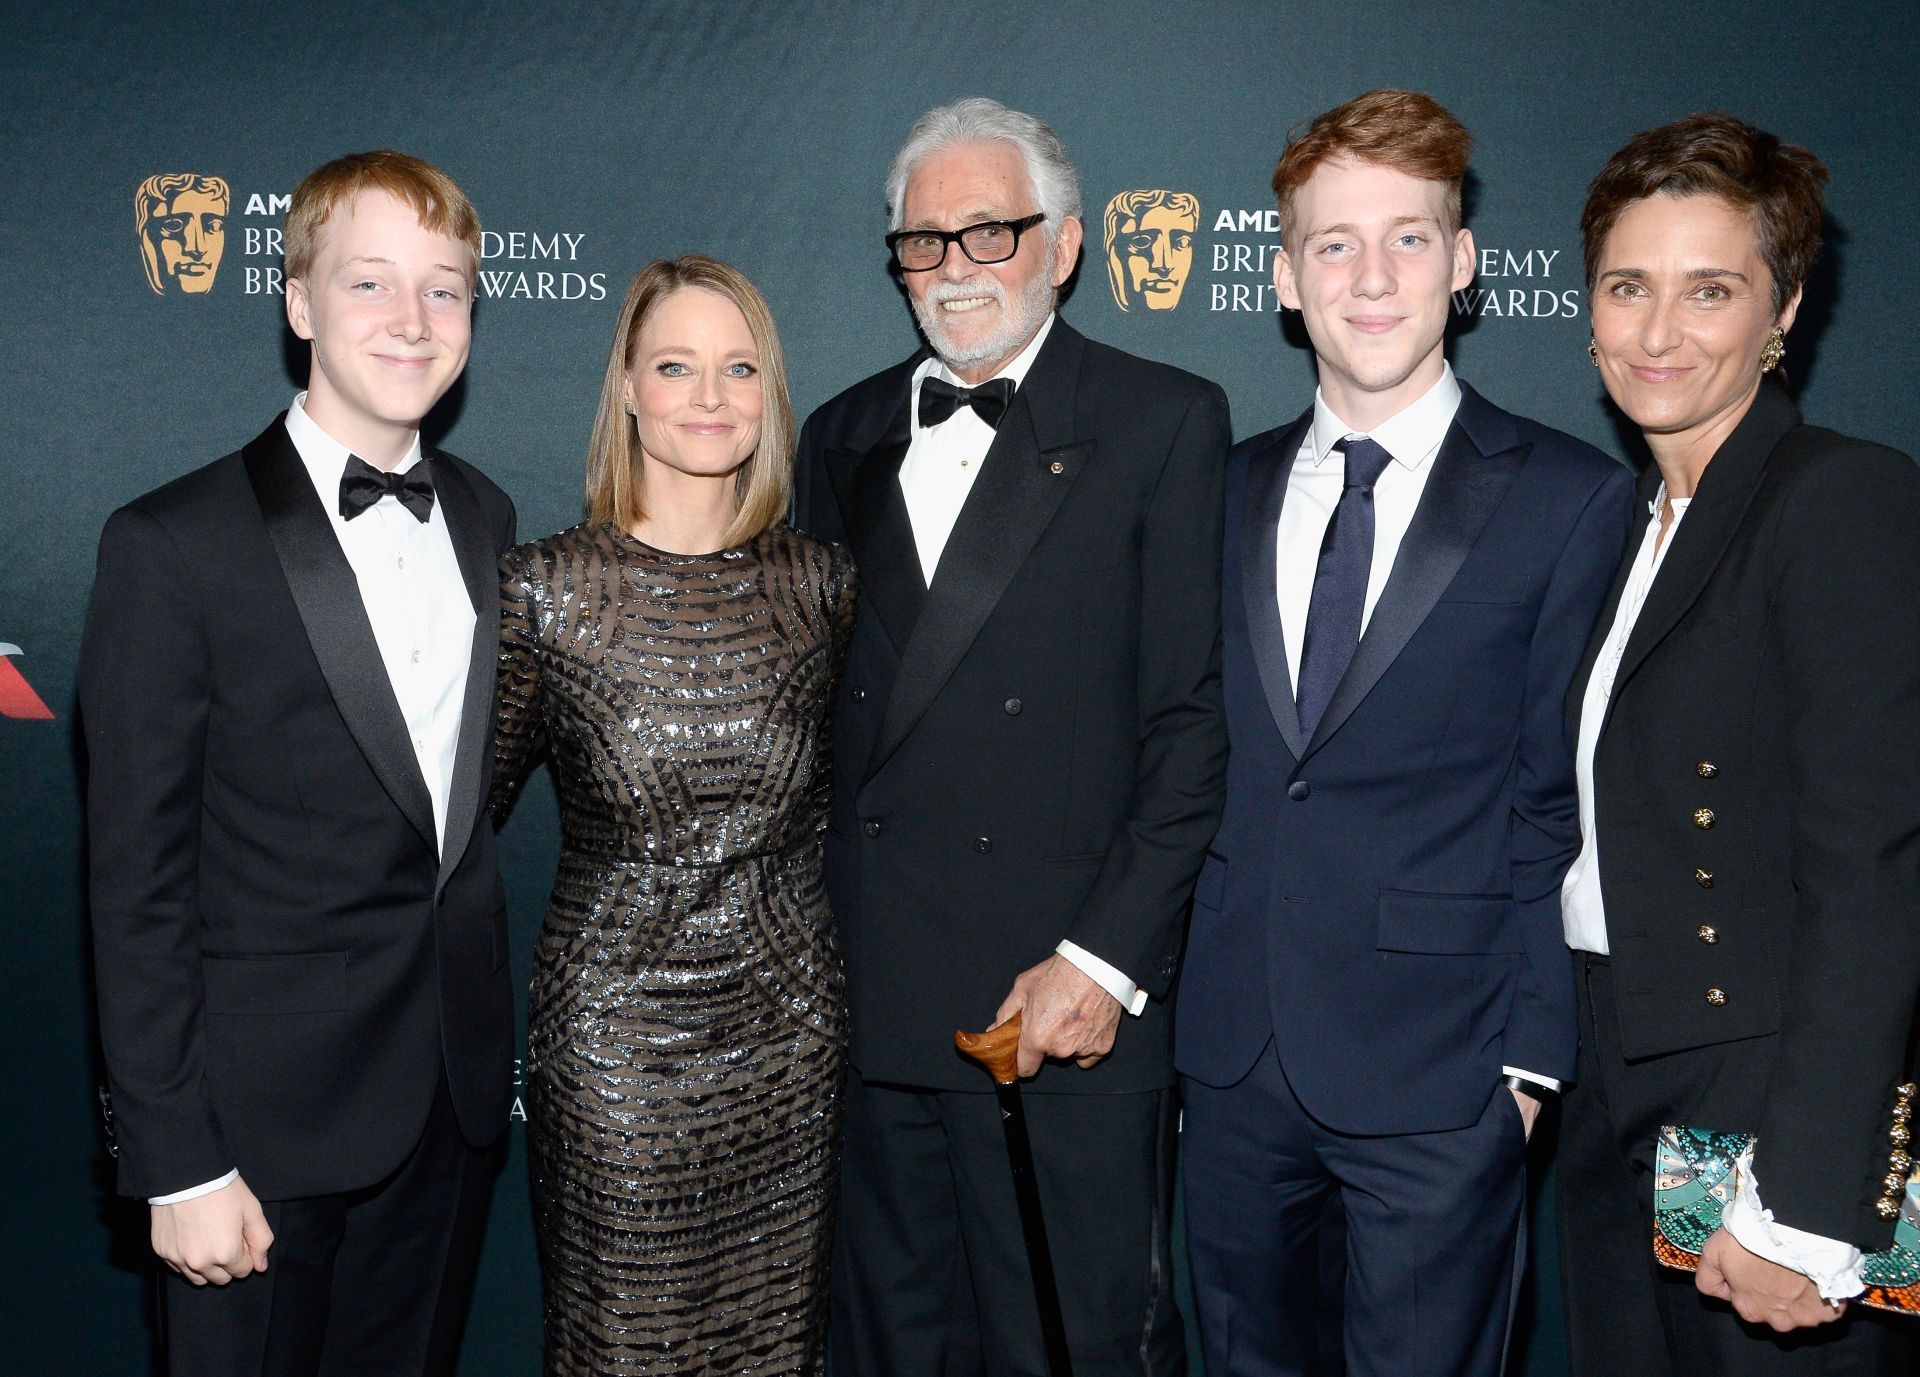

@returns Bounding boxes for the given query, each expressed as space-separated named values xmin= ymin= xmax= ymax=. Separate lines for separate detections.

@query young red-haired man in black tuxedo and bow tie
xmin=79 ymin=152 xmax=513 ymax=1377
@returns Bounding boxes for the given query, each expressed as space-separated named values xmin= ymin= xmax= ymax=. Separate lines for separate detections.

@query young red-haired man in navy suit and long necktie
xmin=1175 ymin=90 xmax=1632 ymax=1377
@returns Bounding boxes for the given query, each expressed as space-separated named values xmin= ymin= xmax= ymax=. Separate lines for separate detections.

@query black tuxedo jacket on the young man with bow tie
xmin=79 ymin=417 xmax=513 ymax=1200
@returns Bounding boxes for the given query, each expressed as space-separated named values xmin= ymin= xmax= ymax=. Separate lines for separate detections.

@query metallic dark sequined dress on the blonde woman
xmin=493 ymin=524 xmax=854 ymax=1375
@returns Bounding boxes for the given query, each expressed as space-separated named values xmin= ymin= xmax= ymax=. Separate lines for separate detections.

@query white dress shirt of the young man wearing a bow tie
xmin=148 ymin=392 xmax=474 ymax=1204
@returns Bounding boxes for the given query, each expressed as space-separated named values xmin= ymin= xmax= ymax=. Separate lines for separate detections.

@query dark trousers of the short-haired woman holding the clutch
xmin=1557 ymin=953 xmax=1914 ymax=1377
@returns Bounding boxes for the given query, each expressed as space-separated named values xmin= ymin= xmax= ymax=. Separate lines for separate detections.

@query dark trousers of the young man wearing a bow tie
xmin=161 ymin=1077 xmax=505 ymax=1377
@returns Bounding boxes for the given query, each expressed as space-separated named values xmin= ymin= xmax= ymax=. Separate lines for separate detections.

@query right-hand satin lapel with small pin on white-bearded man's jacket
xmin=866 ymin=321 xmax=1094 ymax=780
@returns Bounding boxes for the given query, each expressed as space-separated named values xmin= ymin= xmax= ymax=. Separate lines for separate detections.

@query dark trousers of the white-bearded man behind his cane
xmin=831 ymin=1070 xmax=1187 ymax=1377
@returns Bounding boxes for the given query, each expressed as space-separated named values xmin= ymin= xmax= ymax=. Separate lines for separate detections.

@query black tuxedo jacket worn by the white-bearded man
xmin=797 ymin=319 xmax=1231 ymax=1093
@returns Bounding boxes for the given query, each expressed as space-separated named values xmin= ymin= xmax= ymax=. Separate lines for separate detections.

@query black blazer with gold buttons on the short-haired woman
xmin=1569 ymin=384 xmax=1920 ymax=1246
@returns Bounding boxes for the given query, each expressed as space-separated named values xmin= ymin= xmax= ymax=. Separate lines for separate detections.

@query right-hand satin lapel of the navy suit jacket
xmin=1306 ymin=397 xmax=1532 ymax=755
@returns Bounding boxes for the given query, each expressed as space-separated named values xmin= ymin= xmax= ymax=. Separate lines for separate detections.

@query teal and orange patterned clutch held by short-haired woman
xmin=1653 ymin=1123 xmax=1920 ymax=1316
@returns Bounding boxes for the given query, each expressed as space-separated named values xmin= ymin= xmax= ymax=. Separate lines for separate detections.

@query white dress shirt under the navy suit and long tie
xmin=1273 ymin=363 xmax=1561 ymax=1091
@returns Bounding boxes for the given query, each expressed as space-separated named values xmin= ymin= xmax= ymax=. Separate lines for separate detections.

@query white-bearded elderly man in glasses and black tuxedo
xmin=795 ymin=98 xmax=1231 ymax=1377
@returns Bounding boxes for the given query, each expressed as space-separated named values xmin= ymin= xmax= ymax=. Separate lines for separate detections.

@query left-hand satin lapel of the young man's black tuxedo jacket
xmin=242 ymin=423 xmax=438 ymax=847
